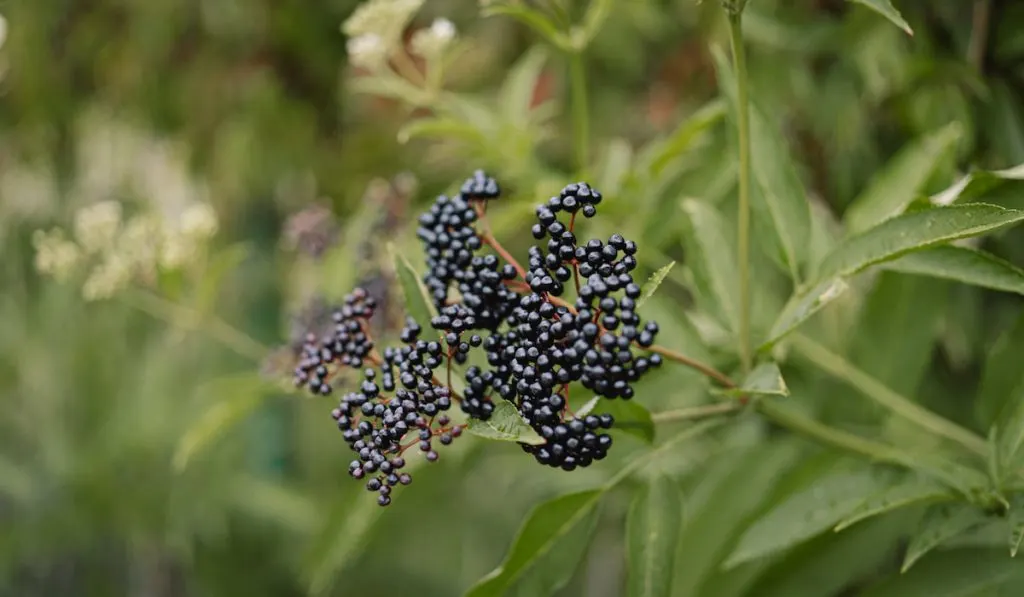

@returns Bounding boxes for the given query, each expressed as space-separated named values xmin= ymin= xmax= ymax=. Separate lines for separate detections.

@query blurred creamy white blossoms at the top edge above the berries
xmin=342 ymin=0 xmax=456 ymax=71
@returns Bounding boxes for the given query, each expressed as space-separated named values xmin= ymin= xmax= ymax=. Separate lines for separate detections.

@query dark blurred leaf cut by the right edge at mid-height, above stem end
xmin=974 ymin=313 xmax=1024 ymax=427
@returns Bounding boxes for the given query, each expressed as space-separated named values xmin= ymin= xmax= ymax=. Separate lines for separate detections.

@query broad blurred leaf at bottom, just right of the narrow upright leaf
xmin=673 ymin=441 xmax=802 ymax=597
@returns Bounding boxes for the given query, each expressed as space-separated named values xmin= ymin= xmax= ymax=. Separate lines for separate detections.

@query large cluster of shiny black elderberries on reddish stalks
xmin=295 ymin=171 xmax=662 ymax=506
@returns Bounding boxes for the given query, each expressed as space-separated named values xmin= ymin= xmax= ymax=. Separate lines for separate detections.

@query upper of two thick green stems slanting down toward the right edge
xmin=791 ymin=334 xmax=988 ymax=458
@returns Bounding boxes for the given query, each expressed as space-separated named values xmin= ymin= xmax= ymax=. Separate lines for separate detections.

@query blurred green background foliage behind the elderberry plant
xmin=6 ymin=0 xmax=1024 ymax=597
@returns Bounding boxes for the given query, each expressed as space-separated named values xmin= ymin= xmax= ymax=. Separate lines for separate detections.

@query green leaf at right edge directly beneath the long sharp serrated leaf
xmin=883 ymin=246 xmax=1024 ymax=294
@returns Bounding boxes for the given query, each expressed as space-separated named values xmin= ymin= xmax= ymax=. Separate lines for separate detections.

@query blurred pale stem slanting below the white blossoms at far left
xmin=122 ymin=290 xmax=269 ymax=363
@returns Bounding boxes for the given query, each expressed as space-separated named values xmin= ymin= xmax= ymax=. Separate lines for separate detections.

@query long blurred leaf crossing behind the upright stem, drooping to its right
xmin=714 ymin=46 xmax=811 ymax=283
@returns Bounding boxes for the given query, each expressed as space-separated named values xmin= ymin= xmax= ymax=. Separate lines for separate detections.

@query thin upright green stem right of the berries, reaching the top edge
xmin=729 ymin=10 xmax=753 ymax=373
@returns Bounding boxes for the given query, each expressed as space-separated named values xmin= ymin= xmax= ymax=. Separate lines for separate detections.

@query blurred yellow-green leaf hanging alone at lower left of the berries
xmin=171 ymin=373 xmax=272 ymax=472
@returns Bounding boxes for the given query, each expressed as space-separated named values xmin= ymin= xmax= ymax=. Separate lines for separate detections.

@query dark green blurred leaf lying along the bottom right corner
xmin=860 ymin=549 xmax=1024 ymax=597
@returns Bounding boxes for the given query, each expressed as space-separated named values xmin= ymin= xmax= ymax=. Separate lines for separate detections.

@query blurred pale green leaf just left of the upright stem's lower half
xmin=682 ymin=199 xmax=739 ymax=332
